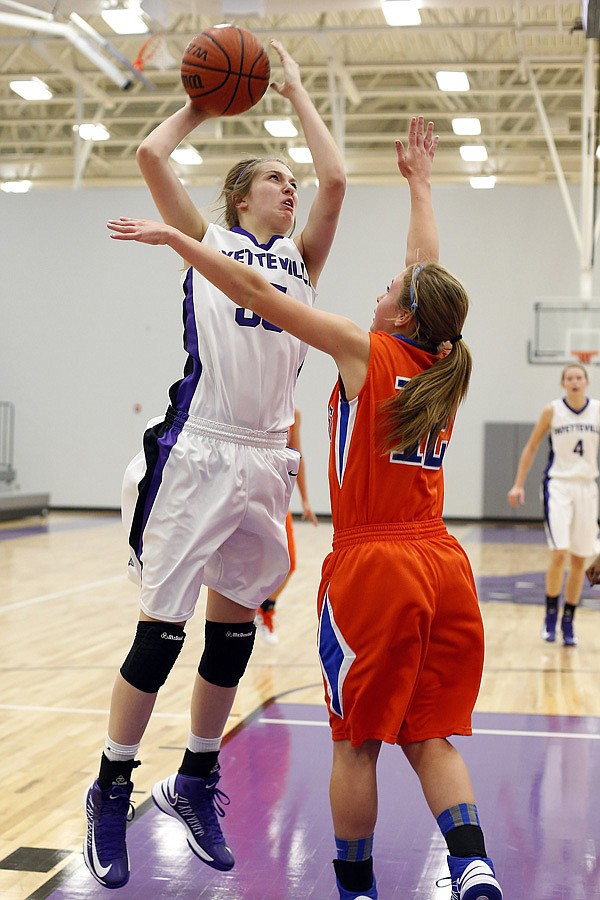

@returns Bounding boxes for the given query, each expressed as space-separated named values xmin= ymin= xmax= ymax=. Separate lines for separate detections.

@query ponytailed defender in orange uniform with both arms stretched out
xmin=109 ymin=117 xmax=502 ymax=900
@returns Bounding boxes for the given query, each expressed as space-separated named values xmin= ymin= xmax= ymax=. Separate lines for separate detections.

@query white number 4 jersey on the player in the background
xmin=546 ymin=398 xmax=600 ymax=481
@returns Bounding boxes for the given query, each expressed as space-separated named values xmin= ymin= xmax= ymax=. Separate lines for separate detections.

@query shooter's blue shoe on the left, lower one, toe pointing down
xmin=83 ymin=781 xmax=135 ymax=888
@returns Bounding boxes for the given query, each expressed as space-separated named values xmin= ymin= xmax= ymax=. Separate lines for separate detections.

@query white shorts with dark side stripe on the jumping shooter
xmin=122 ymin=415 xmax=300 ymax=622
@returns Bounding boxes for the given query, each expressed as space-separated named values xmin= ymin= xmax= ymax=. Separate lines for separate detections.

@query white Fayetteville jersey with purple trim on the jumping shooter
xmin=164 ymin=225 xmax=316 ymax=431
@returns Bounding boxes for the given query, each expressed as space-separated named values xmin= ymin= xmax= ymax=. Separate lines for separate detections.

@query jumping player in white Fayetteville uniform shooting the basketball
xmin=84 ymin=41 xmax=346 ymax=888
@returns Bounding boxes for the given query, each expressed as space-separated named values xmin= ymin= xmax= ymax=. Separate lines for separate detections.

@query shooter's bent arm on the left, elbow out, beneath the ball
xmin=136 ymin=98 xmax=210 ymax=240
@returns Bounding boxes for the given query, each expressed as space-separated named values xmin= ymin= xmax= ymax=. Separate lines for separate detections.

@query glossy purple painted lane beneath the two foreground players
xmin=42 ymin=702 xmax=600 ymax=900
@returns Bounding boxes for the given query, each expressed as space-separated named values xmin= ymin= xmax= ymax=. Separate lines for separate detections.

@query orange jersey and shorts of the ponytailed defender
xmin=317 ymin=332 xmax=484 ymax=746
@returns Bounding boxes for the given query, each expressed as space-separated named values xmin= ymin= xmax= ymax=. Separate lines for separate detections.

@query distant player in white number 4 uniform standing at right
xmin=508 ymin=364 xmax=600 ymax=647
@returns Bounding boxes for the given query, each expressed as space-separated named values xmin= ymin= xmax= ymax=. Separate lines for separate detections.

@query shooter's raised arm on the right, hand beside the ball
xmin=271 ymin=41 xmax=346 ymax=285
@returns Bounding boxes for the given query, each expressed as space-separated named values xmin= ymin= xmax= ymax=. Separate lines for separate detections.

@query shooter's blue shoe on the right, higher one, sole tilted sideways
xmin=152 ymin=771 xmax=235 ymax=872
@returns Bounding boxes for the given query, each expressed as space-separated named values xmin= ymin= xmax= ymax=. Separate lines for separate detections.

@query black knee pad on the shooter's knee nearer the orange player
xmin=198 ymin=622 xmax=256 ymax=687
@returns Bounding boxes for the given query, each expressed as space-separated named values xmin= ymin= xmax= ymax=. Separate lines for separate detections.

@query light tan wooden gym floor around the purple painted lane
xmin=0 ymin=512 xmax=600 ymax=900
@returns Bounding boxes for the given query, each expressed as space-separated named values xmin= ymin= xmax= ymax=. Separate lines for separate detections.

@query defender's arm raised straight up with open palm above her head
xmin=396 ymin=116 xmax=440 ymax=266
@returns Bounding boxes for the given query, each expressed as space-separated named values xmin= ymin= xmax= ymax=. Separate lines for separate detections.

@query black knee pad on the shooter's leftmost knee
xmin=121 ymin=622 xmax=185 ymax=694
